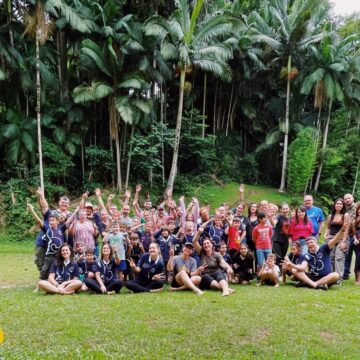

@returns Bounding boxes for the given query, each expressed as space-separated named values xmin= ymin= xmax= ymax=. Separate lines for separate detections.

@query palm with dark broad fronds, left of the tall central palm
xmin=73 ymin=5 xmax=151 ymax=191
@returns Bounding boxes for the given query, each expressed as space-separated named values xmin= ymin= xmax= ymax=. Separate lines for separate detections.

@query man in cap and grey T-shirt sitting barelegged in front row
xmin=167 ymin=242 xmax=204 ymax=295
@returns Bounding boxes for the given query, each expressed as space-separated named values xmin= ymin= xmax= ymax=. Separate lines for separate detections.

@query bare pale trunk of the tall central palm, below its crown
xmin=167 ymin=67 xmax=185 ymax=189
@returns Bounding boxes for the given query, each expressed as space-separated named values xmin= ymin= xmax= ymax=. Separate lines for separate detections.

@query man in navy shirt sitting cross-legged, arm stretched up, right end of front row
xmin=284 ymin=219 xmax=349 ymax=290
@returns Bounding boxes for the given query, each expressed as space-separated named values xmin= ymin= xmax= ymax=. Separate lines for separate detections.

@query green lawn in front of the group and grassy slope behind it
xmin=0 ymin=184 xmax=354 ymax=359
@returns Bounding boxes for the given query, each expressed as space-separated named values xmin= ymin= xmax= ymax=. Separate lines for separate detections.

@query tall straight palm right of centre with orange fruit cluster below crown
xmin=250 ymin=0 xmax=328 ymax=192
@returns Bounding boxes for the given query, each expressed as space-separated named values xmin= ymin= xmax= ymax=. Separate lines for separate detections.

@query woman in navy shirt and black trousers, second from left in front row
xmin=85 ymin=243 xmax=123 ymax=295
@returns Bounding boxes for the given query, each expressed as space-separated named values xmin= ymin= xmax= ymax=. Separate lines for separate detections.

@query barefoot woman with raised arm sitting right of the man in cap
xmin=193 ymin=226 xmax=234 ymax=296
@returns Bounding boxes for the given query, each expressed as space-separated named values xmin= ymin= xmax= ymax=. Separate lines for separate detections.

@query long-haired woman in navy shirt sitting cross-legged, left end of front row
xmin=39 ymin=244 xmax=82 ymax=295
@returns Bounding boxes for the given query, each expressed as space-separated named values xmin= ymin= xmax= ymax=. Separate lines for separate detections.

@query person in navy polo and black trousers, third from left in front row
xmin=124 ymin=243 xmax=165 ymax=293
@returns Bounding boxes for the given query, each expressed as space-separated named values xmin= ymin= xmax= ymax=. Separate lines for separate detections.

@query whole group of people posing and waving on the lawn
xmin=28 ymin=185 xmax=360 ymax=296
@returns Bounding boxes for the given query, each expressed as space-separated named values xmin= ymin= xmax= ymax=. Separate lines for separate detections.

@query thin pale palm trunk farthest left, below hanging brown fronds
xmin=35 ymin=28 xmax=45 ymax=192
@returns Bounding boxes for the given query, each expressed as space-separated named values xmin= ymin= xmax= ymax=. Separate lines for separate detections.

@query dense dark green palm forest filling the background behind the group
xmin=0 ymin=0 xmax=360 ymax=222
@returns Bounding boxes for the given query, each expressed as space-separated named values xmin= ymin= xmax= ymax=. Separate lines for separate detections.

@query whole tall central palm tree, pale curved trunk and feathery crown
xmin=145 ymin=0 xmax=232 ymax=189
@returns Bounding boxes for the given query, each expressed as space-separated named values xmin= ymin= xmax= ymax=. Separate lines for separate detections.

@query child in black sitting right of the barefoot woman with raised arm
xmin=233 ymin=244 xmax=254 ymax=285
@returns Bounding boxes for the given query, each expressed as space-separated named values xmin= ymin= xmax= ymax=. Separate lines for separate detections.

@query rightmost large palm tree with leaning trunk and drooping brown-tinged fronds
xmin=301 ymin=32 xmax=360 ymax=192
